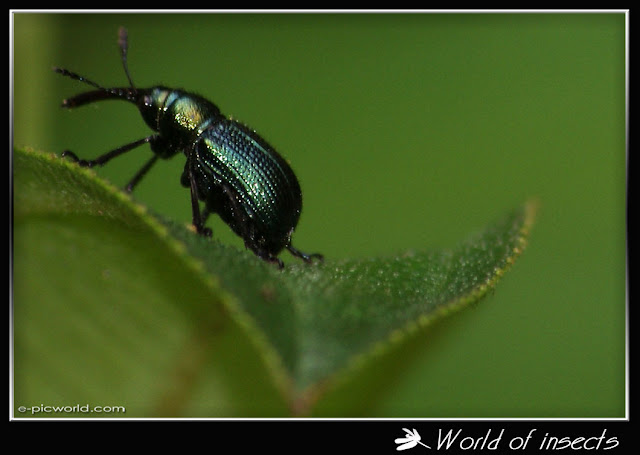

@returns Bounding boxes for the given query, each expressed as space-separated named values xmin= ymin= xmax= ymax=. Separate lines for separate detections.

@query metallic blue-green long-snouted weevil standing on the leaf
xmin=53 ymin=27 xmax=323 ymax=268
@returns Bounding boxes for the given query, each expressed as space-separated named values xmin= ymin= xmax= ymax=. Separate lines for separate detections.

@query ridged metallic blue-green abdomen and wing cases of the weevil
xmin=196 ymin=119 xmax=302 ymax=254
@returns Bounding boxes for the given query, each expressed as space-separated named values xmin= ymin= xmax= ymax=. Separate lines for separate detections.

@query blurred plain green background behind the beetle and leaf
xmin=13 ymin=13 xmax=626 ymax=417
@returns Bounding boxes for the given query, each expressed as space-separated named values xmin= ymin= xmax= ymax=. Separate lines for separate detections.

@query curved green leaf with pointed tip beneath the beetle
xmin=13 ymin=150 xmax=536 ymax=417
